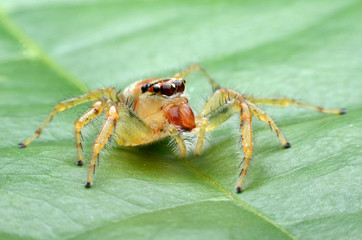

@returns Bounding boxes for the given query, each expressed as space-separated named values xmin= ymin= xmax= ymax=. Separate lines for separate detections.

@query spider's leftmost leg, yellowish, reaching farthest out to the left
xmin=19 ymin=88 xmax=117 ymax=148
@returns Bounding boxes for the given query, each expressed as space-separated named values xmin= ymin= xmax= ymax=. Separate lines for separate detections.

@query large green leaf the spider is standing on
xmin=0 ymin=0 xmax=362 ymax=239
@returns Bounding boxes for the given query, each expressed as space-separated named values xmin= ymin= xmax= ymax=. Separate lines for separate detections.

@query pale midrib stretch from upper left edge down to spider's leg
xmin=0 ymin=6 xmax=89 ymax=92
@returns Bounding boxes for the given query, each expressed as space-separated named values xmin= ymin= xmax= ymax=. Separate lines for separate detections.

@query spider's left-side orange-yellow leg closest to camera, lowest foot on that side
xmin=85 ymin=105 xmax=118 ymax=187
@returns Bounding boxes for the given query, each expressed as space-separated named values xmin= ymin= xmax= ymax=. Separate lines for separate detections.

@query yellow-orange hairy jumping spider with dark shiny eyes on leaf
xmin=19 ymin=64 xmax=346 ymax=192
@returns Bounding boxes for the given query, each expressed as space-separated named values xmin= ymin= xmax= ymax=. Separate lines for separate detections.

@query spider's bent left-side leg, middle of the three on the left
xmin=74 ymin=99 xmax=111 ymax=166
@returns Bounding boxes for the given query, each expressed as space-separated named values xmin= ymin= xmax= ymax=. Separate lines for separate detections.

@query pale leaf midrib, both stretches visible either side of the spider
xmin=0 ymin=3 xmax=297 ymax=239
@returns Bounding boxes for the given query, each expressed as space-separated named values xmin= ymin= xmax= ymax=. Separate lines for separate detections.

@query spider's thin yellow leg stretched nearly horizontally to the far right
xmin=244 ymin=96 xmax=346 ymax=114
